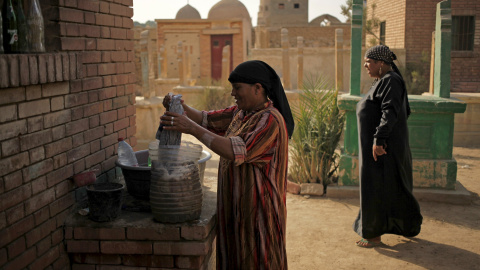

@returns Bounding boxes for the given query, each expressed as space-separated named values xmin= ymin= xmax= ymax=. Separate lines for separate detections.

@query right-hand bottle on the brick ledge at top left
xmin=27 ymin=0 xmax=45 ymax=53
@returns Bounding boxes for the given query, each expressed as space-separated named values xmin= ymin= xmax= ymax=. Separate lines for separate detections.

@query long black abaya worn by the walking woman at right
xmin=353 ymin=72 xmax=423 ymax=238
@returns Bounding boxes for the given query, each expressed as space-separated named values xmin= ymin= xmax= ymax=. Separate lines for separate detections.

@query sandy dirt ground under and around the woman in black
xmin=195 ymin=133 xmax=480 ymax=270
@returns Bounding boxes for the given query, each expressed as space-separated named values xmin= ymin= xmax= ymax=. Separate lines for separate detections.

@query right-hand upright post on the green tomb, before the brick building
xmin=433 ymin=0 xmax=452 ymax=98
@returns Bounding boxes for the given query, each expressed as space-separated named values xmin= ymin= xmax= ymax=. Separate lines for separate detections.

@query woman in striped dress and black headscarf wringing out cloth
xmin=161 ymin=60 xmax=294 ymax=270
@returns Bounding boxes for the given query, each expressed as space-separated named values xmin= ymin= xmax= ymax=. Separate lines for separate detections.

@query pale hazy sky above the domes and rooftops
xmin=133 ymin=0 xmax=346 ymax=26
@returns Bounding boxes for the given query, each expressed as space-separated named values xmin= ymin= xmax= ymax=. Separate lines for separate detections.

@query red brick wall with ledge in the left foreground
xmin=0 ymin=0 xmax=136 ymax=270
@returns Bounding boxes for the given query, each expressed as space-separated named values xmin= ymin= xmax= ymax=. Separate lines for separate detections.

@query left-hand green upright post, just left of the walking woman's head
xmin=350 ymin=0 xmax=363 ymax=95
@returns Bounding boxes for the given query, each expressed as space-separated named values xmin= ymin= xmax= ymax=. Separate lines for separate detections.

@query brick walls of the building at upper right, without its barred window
xmin=368 ymin=0 xmax=480 ymax=92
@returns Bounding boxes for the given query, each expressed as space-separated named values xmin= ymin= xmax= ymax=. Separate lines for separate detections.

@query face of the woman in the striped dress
xmin=231 ymin=83 xmax=263 ymax=112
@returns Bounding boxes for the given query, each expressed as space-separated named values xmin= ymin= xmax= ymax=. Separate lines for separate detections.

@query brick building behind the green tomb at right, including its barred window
xmin=366 ymin=0 xmax=480 ymax=93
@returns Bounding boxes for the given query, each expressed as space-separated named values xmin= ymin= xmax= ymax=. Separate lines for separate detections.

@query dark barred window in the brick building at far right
xmin=452 ymin=16 xmax=475 ymax=51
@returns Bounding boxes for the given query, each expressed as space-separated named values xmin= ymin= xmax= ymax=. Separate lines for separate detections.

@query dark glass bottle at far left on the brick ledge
xmin=2 ymin=0 xmax=18 ymax=53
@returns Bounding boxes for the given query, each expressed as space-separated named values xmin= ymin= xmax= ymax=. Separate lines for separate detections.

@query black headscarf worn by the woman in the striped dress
xmin=228 ymin=60 xmax=295 ymax=138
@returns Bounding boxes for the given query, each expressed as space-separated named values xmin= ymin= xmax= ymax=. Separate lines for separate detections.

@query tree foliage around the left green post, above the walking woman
xmin=340 ymin=0 xmax=380 ymax=46
